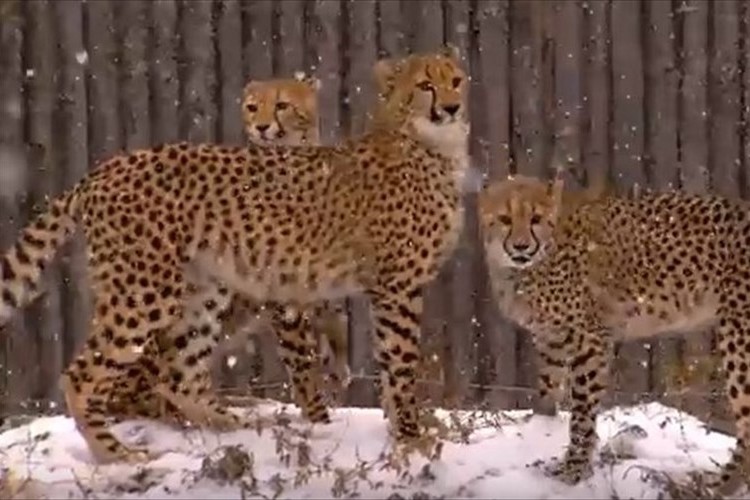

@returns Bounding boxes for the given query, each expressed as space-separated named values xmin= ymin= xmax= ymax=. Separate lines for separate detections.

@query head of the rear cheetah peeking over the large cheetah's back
xmin=242 ymin=73 xmax=320 ymax=145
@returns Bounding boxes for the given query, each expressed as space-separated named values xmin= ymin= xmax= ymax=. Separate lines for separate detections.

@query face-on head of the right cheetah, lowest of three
xmin=478 ymin=176 xmax=563 ymax=268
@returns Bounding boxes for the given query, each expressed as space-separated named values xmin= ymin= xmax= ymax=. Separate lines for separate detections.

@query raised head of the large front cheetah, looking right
xmin=374 ymin=46 xmax=469 ymax=145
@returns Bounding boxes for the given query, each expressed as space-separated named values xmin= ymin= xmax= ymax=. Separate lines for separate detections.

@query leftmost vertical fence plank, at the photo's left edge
xmin=0 ymin=1 xmax=29 ymax=414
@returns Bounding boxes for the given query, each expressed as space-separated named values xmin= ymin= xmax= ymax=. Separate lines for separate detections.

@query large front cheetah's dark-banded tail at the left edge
xmin=0 ymin=190 xmax=77 ymax=325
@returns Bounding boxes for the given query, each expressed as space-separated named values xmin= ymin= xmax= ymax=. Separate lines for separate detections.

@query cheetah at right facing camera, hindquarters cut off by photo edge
xmin=478 ymin=176 xmax=750 ymax=494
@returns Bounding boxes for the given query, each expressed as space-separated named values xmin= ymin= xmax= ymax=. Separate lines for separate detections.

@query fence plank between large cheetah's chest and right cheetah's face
xmin=443 ymin=0 xmax=478 ymax=407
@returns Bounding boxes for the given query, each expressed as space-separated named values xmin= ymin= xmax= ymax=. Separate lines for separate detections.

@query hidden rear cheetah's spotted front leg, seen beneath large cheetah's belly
xmin=273 ymin=306 xmax=331 ymax=424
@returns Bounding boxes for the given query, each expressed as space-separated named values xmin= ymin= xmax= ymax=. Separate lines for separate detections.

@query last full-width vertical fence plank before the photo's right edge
xmin=709 ymin=0 xmax=742 ymax=197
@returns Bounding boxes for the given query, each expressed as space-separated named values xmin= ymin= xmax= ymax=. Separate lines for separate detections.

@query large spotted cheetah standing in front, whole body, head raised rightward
xmin=0 ymin=48 xmax=469 ymax=463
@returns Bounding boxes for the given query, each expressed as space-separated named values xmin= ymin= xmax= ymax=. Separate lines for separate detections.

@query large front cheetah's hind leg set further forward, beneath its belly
xmin=155 ymin=278 xmax=247 ymax=430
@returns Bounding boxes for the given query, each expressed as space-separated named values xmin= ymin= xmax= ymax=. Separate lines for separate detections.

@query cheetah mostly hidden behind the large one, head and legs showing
xmin=107 ymin=72 xmax=350 ymax=425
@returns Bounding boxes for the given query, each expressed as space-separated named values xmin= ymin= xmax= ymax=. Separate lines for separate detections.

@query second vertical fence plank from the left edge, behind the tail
xmin=22 ymin=1 xmax=63 ymax=406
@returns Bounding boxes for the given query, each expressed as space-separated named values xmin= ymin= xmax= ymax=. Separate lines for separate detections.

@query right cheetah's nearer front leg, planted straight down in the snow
xmin=548 ymin=319 xmax=612 ymax=484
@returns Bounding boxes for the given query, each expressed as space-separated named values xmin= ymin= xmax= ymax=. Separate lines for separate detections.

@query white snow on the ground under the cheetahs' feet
xmin=0 ymin=403 xmax=750 ymax=499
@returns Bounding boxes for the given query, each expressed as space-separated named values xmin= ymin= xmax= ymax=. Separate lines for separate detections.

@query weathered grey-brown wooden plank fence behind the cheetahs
xmin=0 ymin=0 xmax=750 ymax=428
